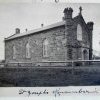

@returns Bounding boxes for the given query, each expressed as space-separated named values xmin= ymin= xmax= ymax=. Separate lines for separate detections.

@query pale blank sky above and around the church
xmin=0 ymin=0 xmax=100 ymax=60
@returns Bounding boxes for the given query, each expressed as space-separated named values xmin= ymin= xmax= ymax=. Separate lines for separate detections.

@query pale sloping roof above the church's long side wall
xmin=5 ymin=21 xmax=65 ymax=41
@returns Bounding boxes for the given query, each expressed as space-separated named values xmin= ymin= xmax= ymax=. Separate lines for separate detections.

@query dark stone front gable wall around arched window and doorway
xmin=66 ymin=16 xmax=92 ymax=60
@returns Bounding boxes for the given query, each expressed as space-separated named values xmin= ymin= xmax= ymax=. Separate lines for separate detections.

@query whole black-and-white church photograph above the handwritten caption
xmin=0 ymin=0 xmax=100 ymax=87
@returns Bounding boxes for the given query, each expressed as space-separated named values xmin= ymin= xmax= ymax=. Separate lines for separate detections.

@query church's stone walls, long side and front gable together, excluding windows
xmin=5 ymin=16 xmax=92 ymax=62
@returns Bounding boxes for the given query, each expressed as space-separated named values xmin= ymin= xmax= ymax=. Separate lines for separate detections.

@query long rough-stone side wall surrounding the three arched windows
xmin=5 ymin=26 xmax=67 ymax=62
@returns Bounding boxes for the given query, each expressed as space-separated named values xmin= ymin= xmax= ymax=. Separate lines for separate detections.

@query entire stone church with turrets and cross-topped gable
xmin=5 ymin=7 xmax=93 ymax=62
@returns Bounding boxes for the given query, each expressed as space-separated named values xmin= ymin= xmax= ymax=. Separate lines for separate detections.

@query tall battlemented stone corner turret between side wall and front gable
xmin=63 ymin=7 xmax=73 ymax=60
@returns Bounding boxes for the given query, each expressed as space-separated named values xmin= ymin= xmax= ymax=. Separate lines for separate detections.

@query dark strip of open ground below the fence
xmin=0 ymin=65 xmax=100 ymax=87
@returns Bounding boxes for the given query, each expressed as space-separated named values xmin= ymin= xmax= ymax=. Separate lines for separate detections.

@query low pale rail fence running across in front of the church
xmin=0 ymin=60 xmax=100 ymax=67
